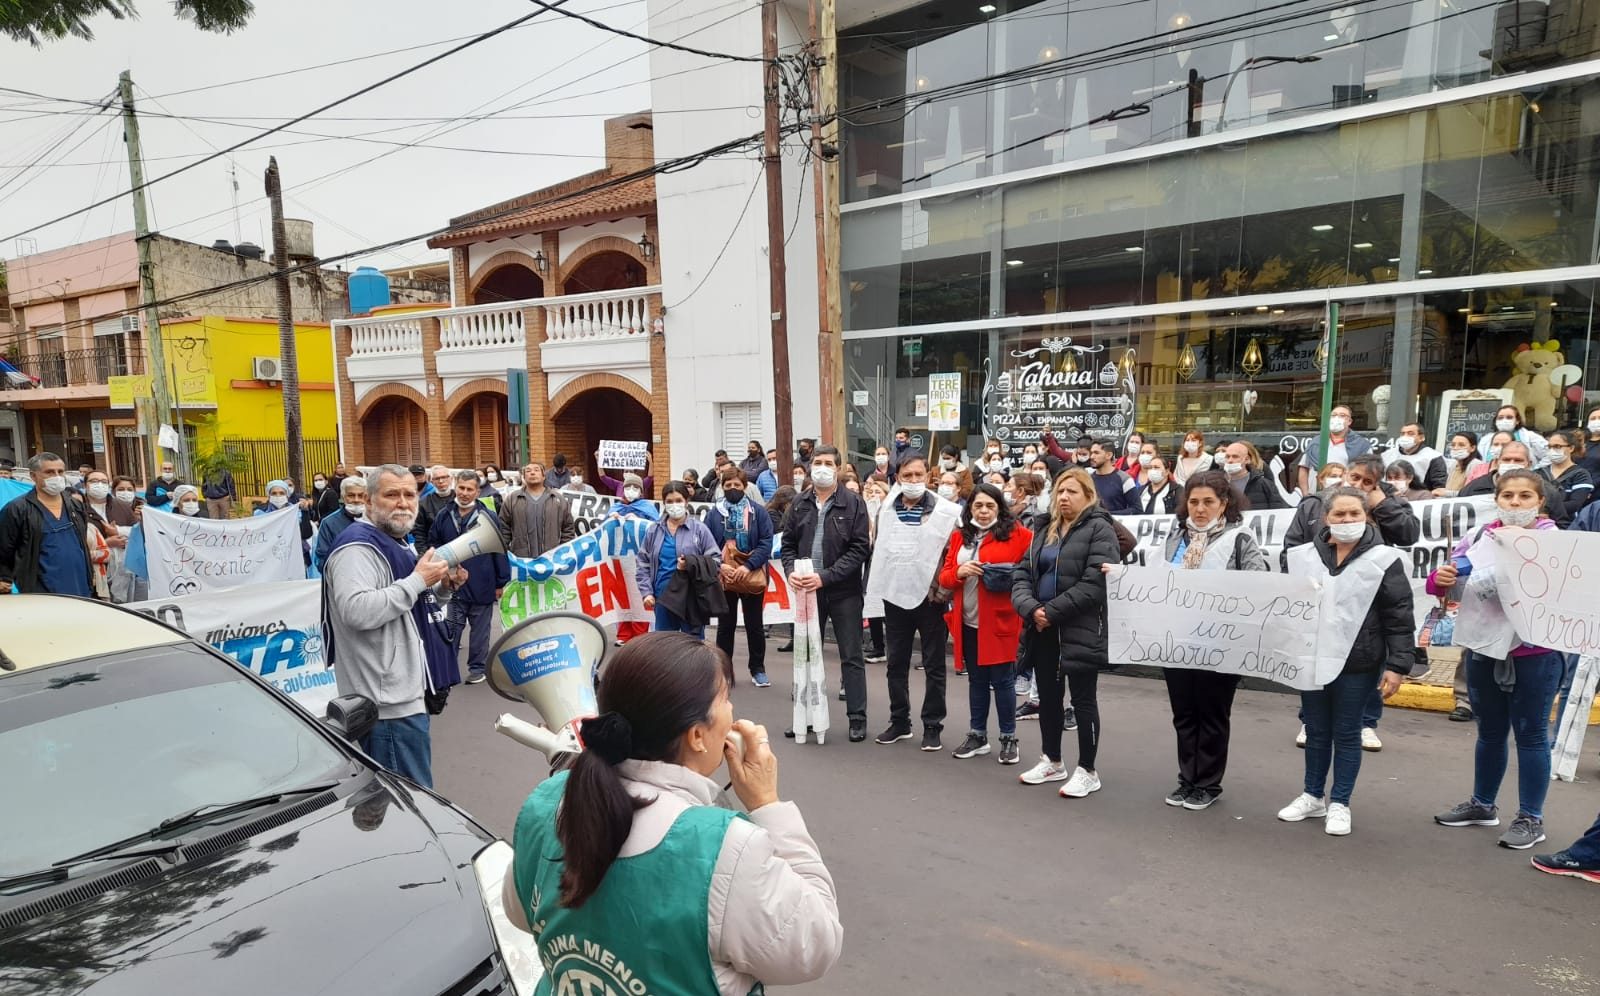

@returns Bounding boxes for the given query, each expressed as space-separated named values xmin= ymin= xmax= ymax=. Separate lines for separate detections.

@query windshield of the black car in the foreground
xmin=0 ymin=644 xmax=350 ymax=878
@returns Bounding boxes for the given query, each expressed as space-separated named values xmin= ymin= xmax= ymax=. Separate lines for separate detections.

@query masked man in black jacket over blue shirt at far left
xmin=0 ymin=453 xmax=95 ymax=602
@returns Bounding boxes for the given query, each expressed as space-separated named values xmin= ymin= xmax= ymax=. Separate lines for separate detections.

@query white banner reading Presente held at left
xmin=144 ymin=506 xmax=306 ymax=596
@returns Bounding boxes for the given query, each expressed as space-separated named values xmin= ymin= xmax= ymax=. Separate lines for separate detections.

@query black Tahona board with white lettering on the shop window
xmin=984 ymin=336 xmax=1136 ymax=456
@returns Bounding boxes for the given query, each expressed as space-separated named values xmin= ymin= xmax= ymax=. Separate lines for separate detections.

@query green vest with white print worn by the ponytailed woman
xmin=512 ymin=772 xmax=762 ymax=996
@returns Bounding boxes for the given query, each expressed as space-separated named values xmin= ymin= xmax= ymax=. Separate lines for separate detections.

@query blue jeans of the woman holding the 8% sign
xmin=1464 ymin=650 xmax=1565 ymax=820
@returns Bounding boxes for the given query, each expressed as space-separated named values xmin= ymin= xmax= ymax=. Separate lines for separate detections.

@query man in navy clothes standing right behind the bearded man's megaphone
xmin=427 ymin=471 xmax=510 ymax=685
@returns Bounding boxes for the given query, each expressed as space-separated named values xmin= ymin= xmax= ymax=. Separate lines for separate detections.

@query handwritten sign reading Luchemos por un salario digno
xmin=1106 ymin=567 xmax=1336 ymax=690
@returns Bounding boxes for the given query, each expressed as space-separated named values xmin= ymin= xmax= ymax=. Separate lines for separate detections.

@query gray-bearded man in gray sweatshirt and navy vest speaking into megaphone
xmin=322 ymin=464 xmax=466 ymax=788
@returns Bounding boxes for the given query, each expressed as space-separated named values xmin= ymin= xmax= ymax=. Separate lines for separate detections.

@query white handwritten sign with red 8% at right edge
xmin=1474 ymin=528 xmax=1600 ymax=655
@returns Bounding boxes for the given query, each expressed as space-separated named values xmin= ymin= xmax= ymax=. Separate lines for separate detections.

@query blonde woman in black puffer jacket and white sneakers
xmin=1011 ymin=468 xmax=1122 ymax=799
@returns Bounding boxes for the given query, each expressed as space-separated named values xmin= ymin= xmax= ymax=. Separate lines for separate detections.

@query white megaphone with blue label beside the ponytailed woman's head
xmin=483 ymin=611 xmax=610 ymax=767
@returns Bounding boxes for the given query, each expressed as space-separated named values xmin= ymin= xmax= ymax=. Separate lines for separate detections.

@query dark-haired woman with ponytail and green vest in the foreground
xmin=504 ymin=633 xmax=843 ymax=996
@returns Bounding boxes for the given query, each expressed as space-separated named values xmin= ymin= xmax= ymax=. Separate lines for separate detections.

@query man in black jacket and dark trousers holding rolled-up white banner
xmin=782 ymin=447 xmax=872 ymax=743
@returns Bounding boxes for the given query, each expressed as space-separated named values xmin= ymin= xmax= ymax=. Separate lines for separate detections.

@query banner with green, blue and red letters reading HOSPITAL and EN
xmin=499 ymin=518 xmax=794 ymax=626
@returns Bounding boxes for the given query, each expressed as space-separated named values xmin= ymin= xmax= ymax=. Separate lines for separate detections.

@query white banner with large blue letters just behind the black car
xmin=128 ymin=576 xmax=338 ymax=716
